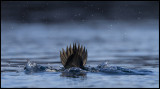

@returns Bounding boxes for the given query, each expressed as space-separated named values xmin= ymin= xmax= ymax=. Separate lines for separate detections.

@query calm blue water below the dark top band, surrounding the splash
xmin=1 ymin=20 xmax=159 ymax=87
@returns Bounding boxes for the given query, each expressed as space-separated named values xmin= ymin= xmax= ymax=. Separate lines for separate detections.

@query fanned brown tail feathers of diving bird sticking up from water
xmin=60 ymin=43 xmax=87 ymax=69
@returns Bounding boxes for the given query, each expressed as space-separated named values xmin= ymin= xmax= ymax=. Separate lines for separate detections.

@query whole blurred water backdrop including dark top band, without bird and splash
xmin=1 ymin=1 xmax=159 ymax=87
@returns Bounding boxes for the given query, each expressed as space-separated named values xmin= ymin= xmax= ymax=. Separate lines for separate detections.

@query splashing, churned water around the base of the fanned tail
xmin=24 ymin=61 xmax=152 ymax=78
